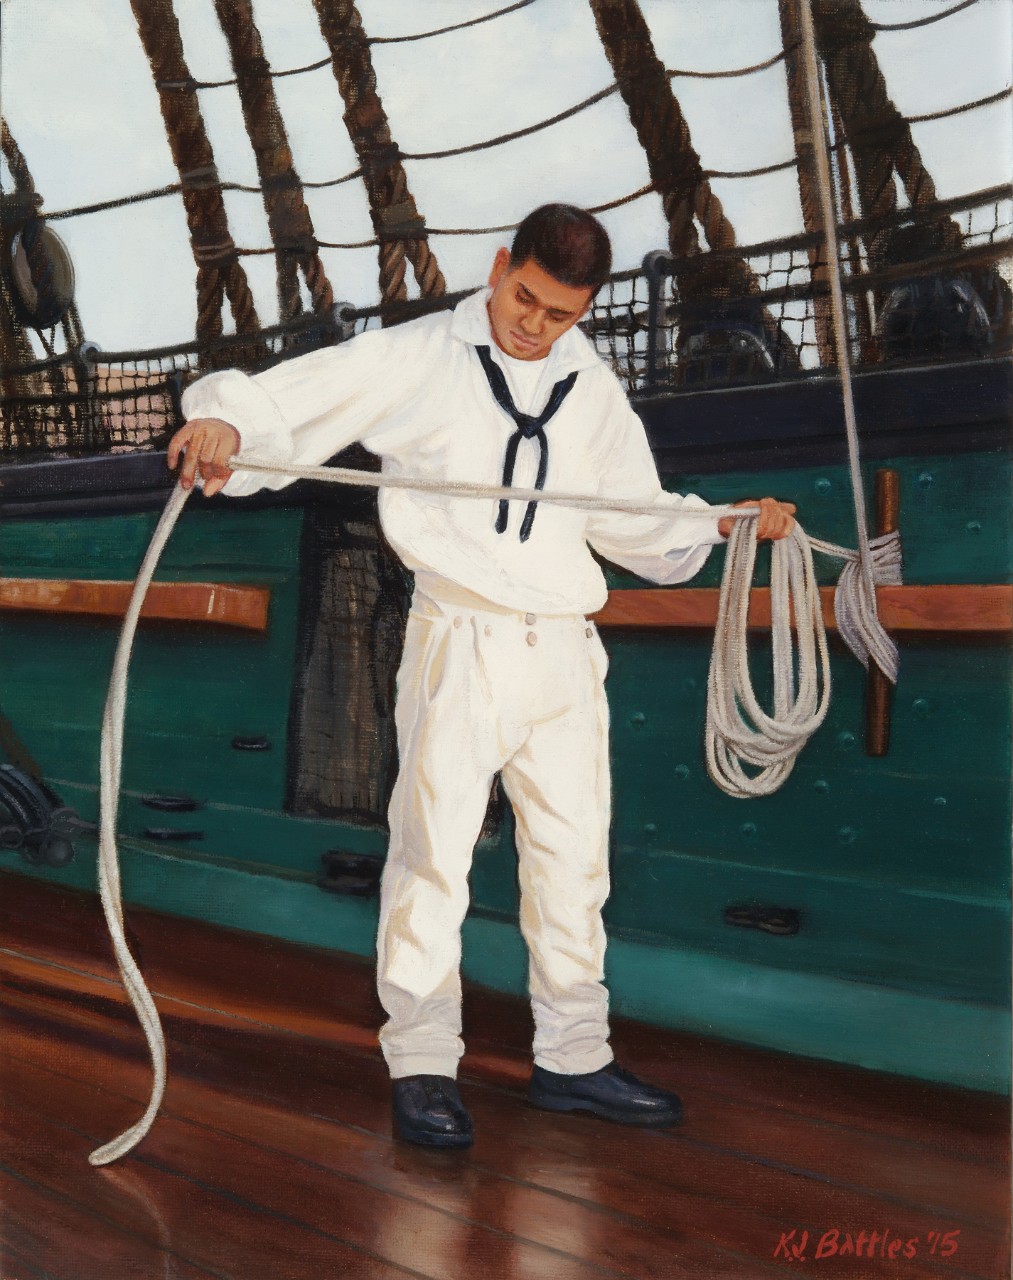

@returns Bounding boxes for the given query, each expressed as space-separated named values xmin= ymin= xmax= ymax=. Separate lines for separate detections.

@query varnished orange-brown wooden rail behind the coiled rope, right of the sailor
xmin=596 ymin=582 xmax=1013 ymax=635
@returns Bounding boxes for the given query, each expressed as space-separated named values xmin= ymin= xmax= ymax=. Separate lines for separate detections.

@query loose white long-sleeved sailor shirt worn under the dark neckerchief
xmin=183 ymin=289 xmax=722 ymax=614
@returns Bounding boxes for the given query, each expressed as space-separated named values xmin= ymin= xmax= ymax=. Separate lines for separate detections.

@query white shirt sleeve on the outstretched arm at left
xmin=182 ymin=330 xmax=417 ymax=497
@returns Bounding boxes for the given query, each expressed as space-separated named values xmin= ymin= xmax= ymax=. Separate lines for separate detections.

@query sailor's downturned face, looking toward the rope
xmin=488 ymin=248 xmax=594 ymax=360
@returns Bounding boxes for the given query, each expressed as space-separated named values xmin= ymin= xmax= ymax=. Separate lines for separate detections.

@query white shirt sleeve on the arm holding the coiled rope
xmin=587 ymin=388 xmax=725 ymax=586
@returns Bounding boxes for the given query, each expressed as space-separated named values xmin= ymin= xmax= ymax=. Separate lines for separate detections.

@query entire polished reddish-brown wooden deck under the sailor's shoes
xmin=0 ymin=873 xmax=1009 ymax=1280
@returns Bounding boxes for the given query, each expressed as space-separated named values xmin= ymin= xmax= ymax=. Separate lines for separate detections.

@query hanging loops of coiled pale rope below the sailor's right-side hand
xmin=704 ymin=516 xmax=830 ymax=799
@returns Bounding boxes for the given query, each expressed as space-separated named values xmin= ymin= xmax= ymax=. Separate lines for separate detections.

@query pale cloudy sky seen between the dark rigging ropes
xmin=0 ymin=0 xmax=1013 ymax=351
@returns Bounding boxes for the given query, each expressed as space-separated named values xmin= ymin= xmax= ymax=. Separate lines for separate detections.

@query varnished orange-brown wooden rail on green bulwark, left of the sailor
xmin=0 ymin=577 xmax=270 ymax=631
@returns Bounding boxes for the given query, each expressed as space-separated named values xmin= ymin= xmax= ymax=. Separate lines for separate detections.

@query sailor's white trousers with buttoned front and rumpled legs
xmin=377 ymin=584 xmax=612 ymax=1079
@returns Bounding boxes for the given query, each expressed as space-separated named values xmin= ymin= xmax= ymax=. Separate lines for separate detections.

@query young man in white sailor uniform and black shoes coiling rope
xmin=169 ymin=205 xmax=794 ymax=1147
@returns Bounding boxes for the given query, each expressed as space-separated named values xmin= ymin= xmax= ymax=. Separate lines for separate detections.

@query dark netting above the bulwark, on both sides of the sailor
xmin=0 ymin=187 xmax=1013 ymax=461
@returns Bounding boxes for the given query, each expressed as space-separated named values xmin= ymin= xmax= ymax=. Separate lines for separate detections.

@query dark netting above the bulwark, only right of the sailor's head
xmin=587 ymin=187 xmax=1013 ymax=393
